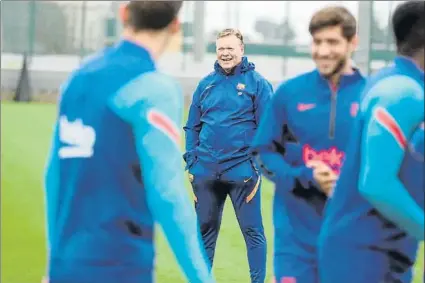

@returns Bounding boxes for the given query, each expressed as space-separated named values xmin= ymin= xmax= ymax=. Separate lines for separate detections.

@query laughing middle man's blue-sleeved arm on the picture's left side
xmin=183 ymin=84 xmax=202 ymax=169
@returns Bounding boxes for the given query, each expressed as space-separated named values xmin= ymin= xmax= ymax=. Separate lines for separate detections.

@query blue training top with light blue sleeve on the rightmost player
xmin=321 ymin=57 xmax=424 ymax=259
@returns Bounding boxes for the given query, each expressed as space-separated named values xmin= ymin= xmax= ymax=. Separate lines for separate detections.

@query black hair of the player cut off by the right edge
xmin=392 ymin=1 xmax=425 ymax=56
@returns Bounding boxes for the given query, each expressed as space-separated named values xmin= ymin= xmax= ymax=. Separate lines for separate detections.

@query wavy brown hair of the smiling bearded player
xmin=308 ymin=6 xmax=357 ymax=40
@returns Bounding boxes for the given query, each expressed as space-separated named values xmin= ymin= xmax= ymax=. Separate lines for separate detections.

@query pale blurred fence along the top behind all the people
xmin=1 ymin=1 xmax=402 ymax=55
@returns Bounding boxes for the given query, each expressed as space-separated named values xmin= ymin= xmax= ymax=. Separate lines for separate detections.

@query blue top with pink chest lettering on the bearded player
xmin=252 ymin=70 xmax=365 ymax=258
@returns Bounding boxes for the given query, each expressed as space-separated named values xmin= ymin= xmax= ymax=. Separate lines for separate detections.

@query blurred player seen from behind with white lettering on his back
xmin=41 ymin=1 xmax=213 ymax=283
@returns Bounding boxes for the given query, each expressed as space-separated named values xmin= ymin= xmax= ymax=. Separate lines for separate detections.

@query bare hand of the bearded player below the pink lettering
xmin=306 ymin=160 xmax=338 ymax=197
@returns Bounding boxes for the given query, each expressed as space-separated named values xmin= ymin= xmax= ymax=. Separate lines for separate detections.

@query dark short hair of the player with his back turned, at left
xmin=126 ymin=0 xmax=183 ymax=31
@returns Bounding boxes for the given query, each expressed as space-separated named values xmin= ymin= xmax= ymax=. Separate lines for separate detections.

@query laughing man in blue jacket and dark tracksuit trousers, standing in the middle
xmin=184 ymin=29 xmax=272 ymax=282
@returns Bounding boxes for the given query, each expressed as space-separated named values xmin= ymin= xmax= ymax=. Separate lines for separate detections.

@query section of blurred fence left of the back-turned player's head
xmin=1 ymin=1 xmax=112 ymax=56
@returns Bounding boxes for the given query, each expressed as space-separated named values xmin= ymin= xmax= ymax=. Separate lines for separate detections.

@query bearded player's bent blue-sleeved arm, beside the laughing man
xmin=252 ymin=85 xmax=313 ymax=188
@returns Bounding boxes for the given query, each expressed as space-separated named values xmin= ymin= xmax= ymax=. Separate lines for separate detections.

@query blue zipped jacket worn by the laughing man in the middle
xmin=183 ymin=57 xmax=273 ymax=174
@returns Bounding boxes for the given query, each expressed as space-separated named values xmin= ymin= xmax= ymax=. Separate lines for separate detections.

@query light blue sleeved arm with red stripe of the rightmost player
xmin=359 ymin=78 xmax=424 ymax=240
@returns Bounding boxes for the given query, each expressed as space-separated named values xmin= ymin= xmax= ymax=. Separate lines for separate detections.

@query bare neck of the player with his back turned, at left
xmin=122 ymin=29 xmax=167 ymax=60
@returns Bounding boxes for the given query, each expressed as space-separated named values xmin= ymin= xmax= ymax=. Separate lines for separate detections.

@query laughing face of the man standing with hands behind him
xmin=216 ymin=35 xmax=244 ymax=72
